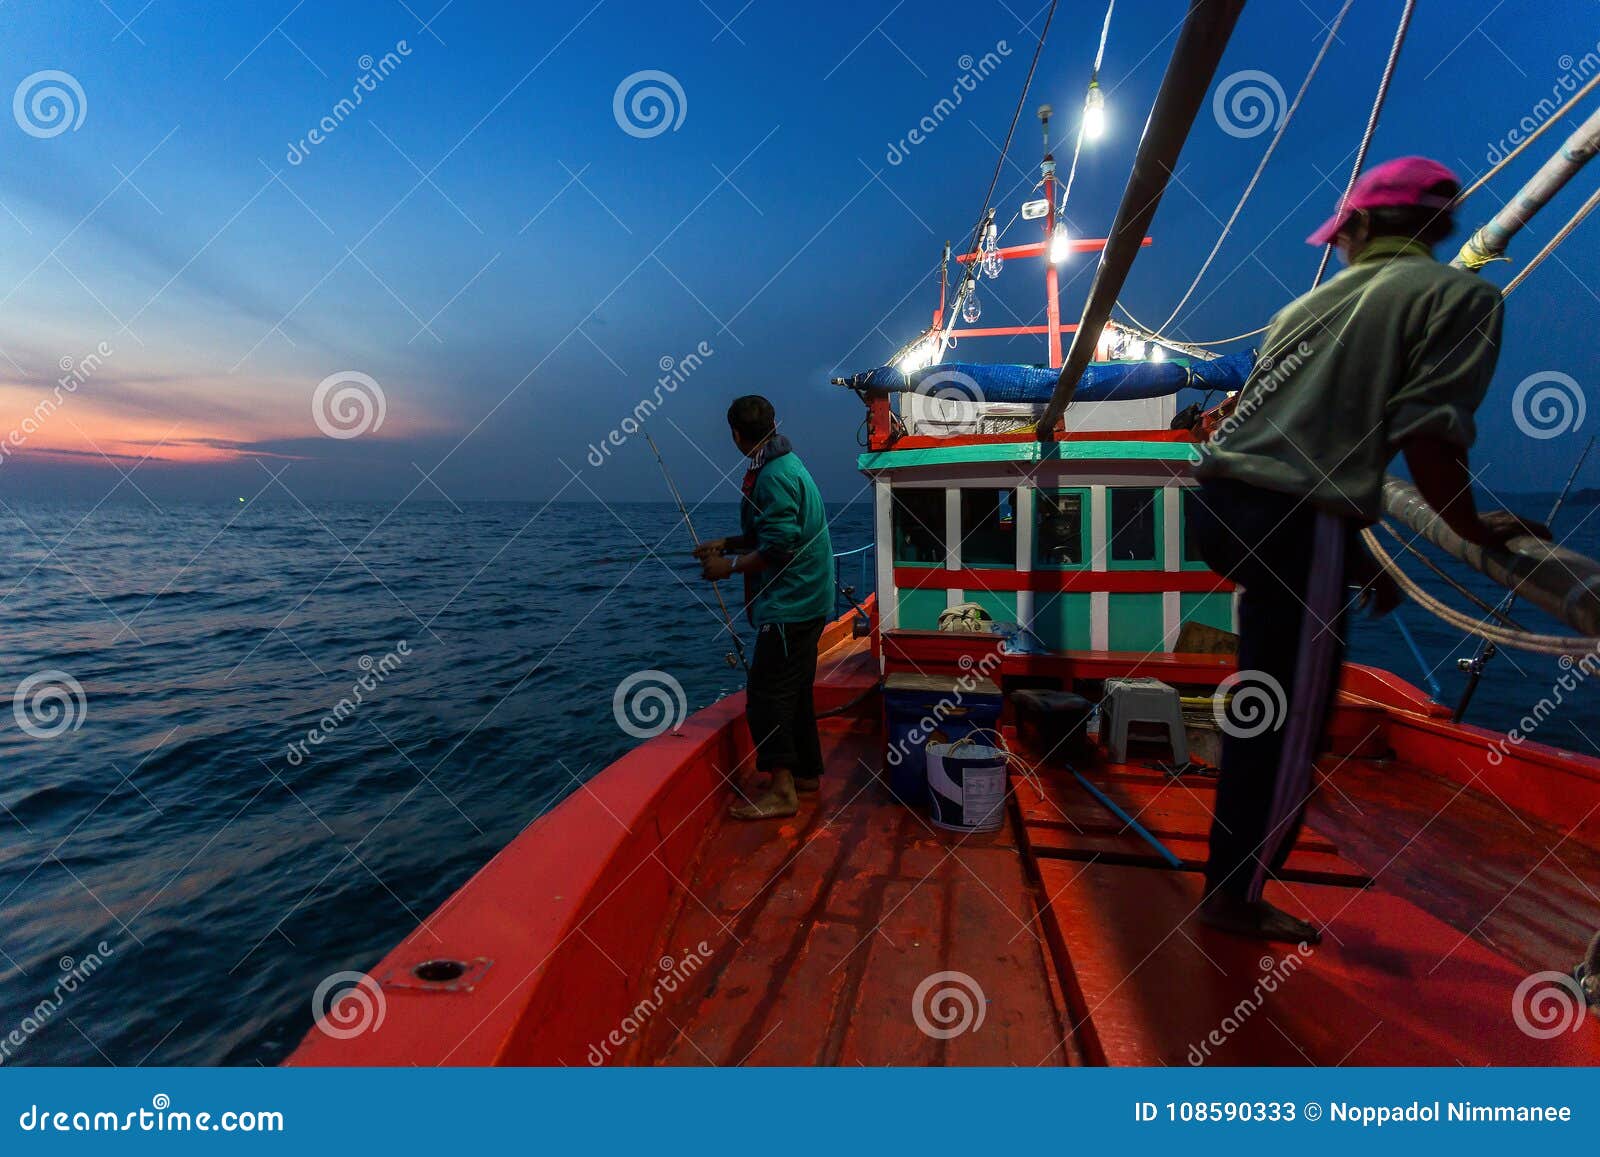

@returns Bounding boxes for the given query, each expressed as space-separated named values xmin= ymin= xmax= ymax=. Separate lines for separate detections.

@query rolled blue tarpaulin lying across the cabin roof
xmin=842 ymin=349 xmax=1256 ymax=405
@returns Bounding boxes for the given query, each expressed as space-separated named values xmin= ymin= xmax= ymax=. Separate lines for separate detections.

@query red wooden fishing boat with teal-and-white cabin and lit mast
xmin=290 ymin=5 xmax=1600 ymax=1066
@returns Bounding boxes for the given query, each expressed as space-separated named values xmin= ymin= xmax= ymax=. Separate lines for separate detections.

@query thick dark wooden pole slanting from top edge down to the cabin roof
xmin=1038 ymin=0 xmax=1245 ymax=442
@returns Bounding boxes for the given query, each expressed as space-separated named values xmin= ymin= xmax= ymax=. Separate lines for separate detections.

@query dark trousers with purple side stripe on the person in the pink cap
xmin=1194 ymin=480 xmax=1352 ymax=899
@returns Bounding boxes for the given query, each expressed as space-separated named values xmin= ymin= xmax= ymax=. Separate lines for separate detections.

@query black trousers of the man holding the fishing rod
xmin=744 ymin=619 xmax=827 ymax=778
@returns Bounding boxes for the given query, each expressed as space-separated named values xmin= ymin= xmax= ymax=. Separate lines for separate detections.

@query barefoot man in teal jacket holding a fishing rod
xmin=694 ymin=394 xmax=834 ymax=819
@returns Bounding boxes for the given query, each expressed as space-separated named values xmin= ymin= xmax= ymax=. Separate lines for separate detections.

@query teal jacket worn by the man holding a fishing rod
xmin=739 ymin=451 xmax=834 ymax=627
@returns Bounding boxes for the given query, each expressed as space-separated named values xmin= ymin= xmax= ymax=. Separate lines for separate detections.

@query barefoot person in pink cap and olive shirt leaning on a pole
xmin=1195 ymin=157 xmax=1549 ymax=943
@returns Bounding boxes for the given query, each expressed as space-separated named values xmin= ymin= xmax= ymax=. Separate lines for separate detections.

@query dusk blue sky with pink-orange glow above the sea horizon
xmin=0 ymin=0 xmax=1600 ymax=501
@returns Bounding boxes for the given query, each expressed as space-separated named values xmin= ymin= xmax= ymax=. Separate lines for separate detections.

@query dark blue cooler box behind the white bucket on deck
xmin=883 ymin=674 xmax=1003 ymax=810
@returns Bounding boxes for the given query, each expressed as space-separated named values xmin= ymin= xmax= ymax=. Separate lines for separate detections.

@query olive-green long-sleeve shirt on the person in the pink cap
xmin=1195 ymin=237 xmax=1502 ymax=523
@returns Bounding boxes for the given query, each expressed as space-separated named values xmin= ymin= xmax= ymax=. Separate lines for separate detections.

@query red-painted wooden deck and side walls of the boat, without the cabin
xmin=291 ymin=611 xmax=1600 ymax=1064
